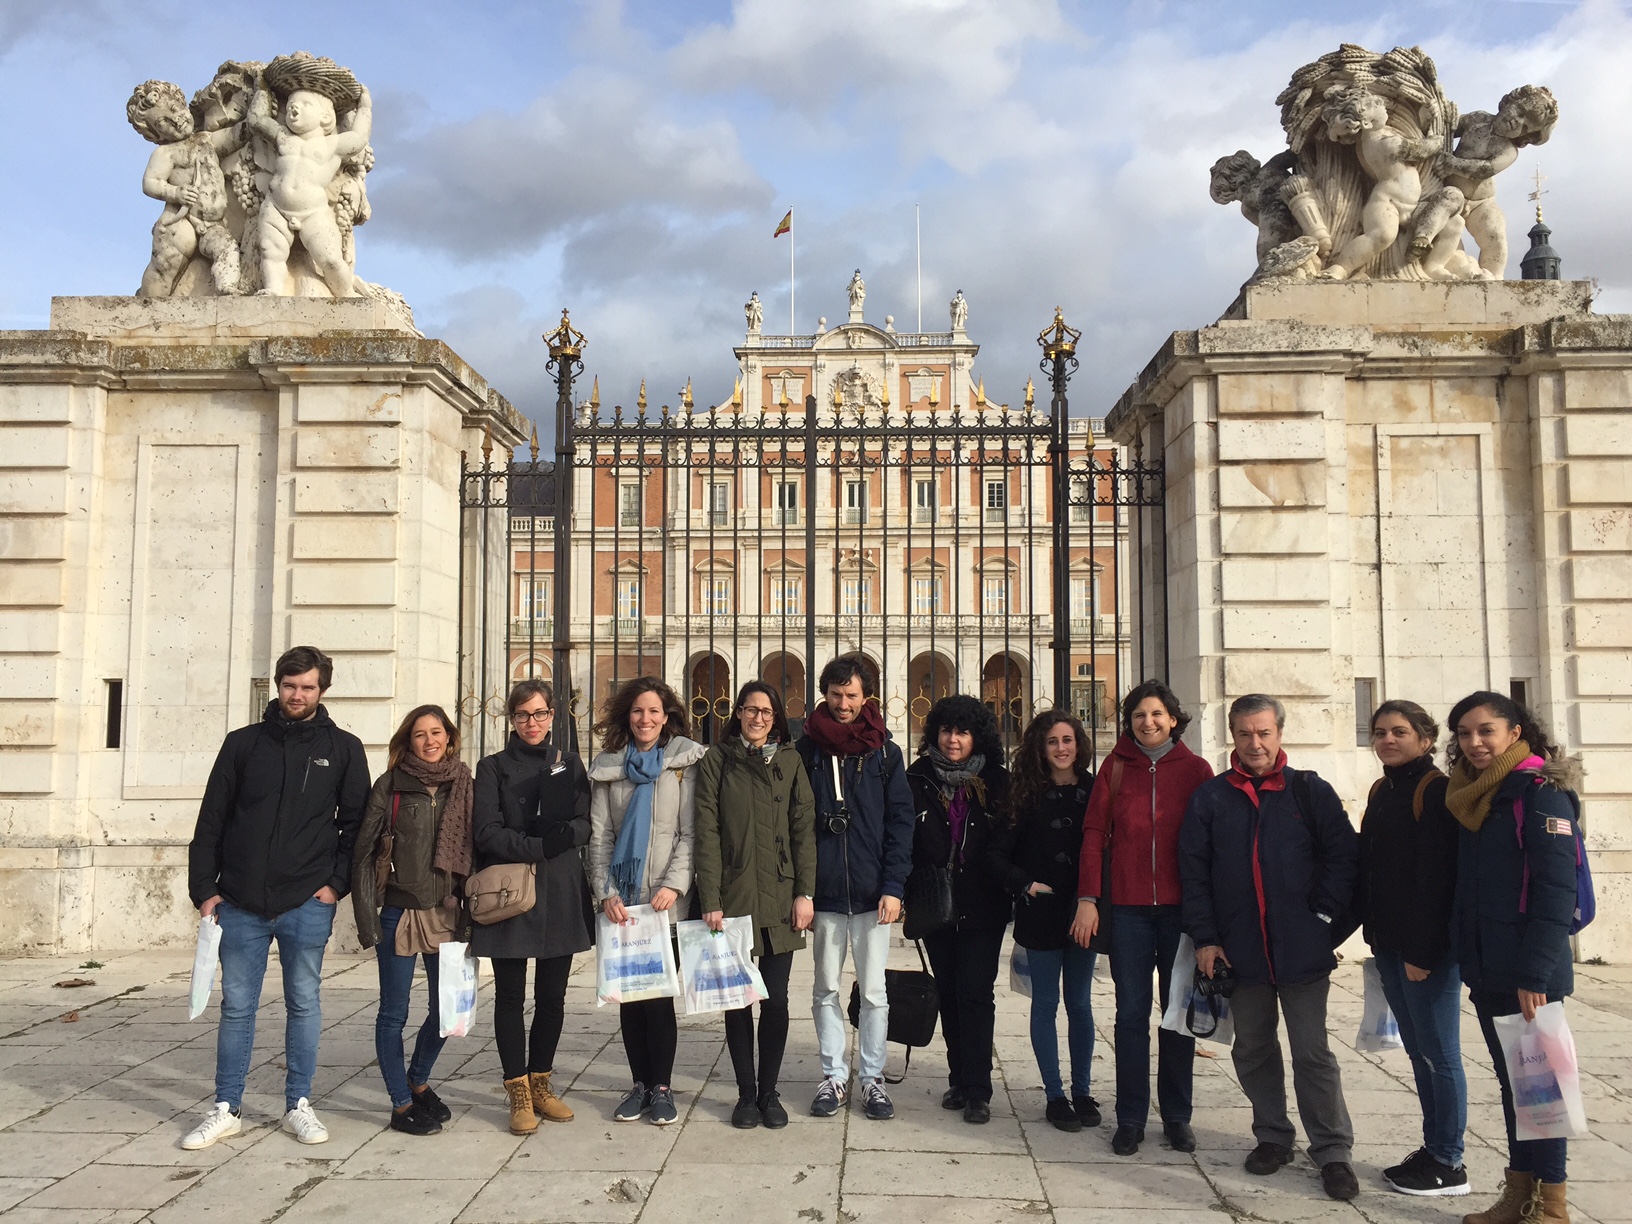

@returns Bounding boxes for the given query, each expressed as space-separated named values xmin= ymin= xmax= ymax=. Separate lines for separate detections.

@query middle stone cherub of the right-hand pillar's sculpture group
xmin=1320 ymin=85 xmax=1443 ymax=281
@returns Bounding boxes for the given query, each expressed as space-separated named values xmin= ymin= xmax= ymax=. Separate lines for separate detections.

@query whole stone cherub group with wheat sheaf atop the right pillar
xmin=1211 ymin=42 xmax=1559 ymax=282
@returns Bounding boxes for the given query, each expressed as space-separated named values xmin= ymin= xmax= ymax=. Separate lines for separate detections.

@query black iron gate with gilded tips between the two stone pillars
xmin=460 ymin=315 xmax=1167 ymax=763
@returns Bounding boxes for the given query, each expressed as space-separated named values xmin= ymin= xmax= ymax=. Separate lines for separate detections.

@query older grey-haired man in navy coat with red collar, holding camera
xmin=1178 ymin=694 xmax=1359 ymax=1200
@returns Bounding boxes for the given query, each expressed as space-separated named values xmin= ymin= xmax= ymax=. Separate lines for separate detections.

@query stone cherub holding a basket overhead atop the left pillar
xmin=246 ymin=55 xmax=372 ymax=297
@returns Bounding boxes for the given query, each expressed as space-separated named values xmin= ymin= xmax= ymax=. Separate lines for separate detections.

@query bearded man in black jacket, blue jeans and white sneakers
xmin=181 ymin=646 xmax=369 ymax=1151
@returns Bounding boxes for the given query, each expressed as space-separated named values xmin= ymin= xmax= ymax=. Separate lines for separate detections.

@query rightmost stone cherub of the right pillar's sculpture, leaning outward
xmin=1412 ymin=85 xmax=1559 ymax=281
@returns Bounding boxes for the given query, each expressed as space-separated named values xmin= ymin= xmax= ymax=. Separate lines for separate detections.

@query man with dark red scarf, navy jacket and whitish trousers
xmin=798 ymin=654 xmax=912 ymax=1120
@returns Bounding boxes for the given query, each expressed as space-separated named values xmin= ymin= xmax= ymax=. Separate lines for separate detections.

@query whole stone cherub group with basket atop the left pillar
xmin=126 ymin=51 xmax=408 ymax=313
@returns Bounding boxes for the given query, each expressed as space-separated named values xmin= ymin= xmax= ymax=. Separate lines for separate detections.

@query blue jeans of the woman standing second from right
xmin=1373 ymin=951 xmax=1467 ymax=1169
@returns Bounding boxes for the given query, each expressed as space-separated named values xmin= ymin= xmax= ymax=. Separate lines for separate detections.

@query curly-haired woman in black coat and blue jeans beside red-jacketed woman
xmin=992 ymin=710 xmax=1100 ymax=1131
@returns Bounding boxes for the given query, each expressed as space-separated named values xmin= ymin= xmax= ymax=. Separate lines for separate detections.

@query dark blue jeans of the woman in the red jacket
xmin=1111 ymin=906 xmax=1196 ymax=1129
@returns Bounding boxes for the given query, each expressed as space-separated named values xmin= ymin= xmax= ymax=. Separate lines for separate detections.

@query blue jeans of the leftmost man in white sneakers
xmin=215 ymin=898 xmax=335 ymax=1113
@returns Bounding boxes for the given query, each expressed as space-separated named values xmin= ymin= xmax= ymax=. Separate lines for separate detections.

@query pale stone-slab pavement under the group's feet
xmin=0 ymin=948 xmax=1632 ymax=1224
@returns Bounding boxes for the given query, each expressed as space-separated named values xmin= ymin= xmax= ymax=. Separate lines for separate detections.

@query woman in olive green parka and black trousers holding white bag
xmin=695 ymin=681 xmax=816 ymax=1129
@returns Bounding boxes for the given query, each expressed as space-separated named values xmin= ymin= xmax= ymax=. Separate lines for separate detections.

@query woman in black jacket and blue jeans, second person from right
xmin=1355 ymin=700 xmax=1467 ymax=1196
